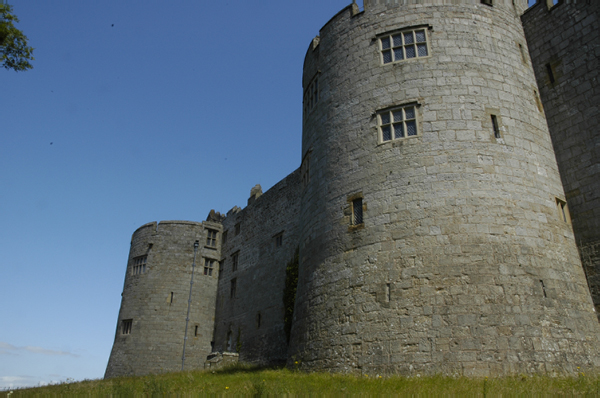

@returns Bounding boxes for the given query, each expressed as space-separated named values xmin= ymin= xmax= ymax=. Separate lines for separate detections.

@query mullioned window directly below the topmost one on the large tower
xmin=377 ymin=105 xmax=417 ymax=142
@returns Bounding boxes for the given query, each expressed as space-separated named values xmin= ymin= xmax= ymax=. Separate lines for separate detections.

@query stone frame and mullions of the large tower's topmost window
xmin=376 ymin=25 xmax=431 ymax=65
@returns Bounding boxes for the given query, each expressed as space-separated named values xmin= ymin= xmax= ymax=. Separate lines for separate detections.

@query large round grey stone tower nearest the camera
xmin=290 ymin=0 xmax=600 ymax=376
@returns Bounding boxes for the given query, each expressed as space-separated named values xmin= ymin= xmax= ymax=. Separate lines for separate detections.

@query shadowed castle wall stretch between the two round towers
xmin=214 ymin=170 xmax=301 ymax=364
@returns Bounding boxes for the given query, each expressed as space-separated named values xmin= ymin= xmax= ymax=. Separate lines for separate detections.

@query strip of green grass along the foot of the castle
xmin=0 ymin=366 xmax=600 ymax=398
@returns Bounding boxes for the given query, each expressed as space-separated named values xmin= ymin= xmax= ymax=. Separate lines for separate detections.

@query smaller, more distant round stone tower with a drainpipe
xmin=105 ymin=221 xmax=221 ymax=378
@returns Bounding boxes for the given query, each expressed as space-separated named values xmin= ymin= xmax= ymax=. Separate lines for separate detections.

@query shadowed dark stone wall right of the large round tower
xmin=522 ymin=1 xmax=600 ymax=315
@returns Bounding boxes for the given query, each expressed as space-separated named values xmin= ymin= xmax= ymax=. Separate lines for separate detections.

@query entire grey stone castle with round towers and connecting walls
xmin=106 ymin=0 xmax=600 ymax=377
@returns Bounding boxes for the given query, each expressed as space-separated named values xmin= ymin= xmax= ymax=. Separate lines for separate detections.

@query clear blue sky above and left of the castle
xmin=0 ymin=0 xmax=540 ymax=389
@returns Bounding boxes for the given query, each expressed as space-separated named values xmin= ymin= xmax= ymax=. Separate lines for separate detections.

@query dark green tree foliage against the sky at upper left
xmin=0 ymin=0 xmax=34 ymax=72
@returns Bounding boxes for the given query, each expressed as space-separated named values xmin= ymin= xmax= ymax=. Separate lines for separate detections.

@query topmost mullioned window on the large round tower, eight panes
xmin=379 ymin=28 xmax=429 ymax=64
